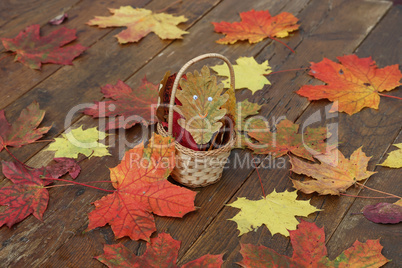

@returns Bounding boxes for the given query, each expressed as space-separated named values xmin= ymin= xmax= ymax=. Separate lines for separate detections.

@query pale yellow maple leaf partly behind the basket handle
xmin=211 ymin=57 xmax=272 ymax=94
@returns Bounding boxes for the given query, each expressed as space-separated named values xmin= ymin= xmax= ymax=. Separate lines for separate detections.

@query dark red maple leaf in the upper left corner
xmin=1 ymin=24 xmax=87 ymax=69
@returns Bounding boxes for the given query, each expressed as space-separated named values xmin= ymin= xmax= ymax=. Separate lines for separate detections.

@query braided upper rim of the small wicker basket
xmin=157 ymin=122 xmax=236 ymax=158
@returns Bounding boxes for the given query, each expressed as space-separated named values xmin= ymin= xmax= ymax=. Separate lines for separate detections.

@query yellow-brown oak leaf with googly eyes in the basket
xmin=176 ymin=66 xmax=229 ymax=144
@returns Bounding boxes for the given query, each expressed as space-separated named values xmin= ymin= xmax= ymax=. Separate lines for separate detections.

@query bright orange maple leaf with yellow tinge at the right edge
xmin=296 ymin=55 xmax=402 ymax=115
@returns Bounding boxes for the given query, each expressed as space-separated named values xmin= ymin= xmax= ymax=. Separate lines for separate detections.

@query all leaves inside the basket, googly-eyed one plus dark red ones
xmin=157 ymin=66 xmax=236 ymax=151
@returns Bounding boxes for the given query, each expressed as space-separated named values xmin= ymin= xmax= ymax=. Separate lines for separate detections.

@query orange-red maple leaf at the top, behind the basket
xmin=212 ymin=10 xmax=299 ymax=44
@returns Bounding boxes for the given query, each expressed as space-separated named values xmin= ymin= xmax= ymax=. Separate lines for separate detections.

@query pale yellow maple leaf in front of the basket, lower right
xmin=228 ymin=190 xmax=320 ymax=236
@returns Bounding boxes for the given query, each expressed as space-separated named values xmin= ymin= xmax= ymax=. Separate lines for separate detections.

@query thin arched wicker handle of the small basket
xmin=168 ymin=53 xmax=235 ymax=136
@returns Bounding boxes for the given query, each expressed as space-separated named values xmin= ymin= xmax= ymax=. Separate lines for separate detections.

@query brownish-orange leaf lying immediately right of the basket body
xmin=248 ymin=119 xmax=334 ymax=160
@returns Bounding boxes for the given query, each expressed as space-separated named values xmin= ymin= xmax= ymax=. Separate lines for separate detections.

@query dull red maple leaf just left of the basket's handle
xmin=84 ymin=77 xmax=158 ymax=130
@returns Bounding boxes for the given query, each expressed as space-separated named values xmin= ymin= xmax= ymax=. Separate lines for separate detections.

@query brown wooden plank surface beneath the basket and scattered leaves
xmin=0 ymin=0 xmax=402 ymax=267
